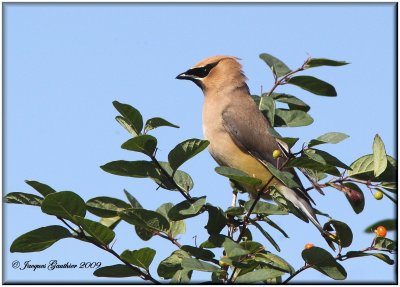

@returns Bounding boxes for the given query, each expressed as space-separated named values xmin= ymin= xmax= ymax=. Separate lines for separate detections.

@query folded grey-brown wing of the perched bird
xmin=222 ymin=100 xmax=315 ymax=204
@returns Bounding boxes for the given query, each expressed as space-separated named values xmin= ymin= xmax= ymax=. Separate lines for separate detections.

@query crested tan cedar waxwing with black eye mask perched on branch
xmin=176 ymin=56 xmax=326 ymax=235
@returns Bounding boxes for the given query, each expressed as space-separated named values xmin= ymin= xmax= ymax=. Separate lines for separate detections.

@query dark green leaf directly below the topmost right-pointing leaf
xmin=287 ymin=76 xmax=337 ymax=97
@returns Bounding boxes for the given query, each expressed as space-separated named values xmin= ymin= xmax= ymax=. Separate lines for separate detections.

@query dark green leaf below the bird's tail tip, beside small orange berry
xmin=301 ymin=247 xmax=347 ymax=280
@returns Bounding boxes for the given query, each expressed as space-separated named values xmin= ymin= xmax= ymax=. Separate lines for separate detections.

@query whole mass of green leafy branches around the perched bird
xmin=4 ymin=53 xmax=397 ymax=284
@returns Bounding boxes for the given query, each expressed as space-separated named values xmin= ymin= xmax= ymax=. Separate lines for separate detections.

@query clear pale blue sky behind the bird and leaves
xmin=3 ymin=3 xmax=397 ymax=283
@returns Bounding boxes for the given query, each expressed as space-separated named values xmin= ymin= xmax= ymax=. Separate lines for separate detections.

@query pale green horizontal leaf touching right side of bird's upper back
xmin=274 ymin=109 xmax=314 ymax=127
